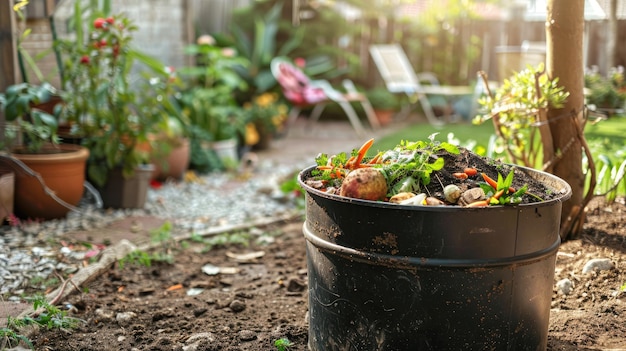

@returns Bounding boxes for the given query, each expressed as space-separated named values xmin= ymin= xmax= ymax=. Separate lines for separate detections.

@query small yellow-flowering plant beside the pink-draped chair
xmin=243 ymin=92 xmax=289 ymax=145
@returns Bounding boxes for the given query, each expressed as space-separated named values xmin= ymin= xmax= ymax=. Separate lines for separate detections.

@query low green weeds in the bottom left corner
xmin=0 ymin=295 xmax=82 ymax=349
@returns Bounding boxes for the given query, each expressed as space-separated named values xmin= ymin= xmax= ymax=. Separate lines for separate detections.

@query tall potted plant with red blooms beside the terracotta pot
xmin=55 ymin=6 xmax=164 ymax=208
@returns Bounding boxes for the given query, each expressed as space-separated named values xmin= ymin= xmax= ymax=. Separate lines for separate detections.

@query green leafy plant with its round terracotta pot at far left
xmin=0 ymin=83 xmax=89 ymax=219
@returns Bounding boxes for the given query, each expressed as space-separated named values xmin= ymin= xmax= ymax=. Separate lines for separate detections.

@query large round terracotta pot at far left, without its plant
xmin=13 ymin=144 xmax=89 ymax=220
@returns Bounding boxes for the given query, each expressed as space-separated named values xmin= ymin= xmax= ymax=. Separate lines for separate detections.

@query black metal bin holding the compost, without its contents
xmin=299 ymin=167 xmax=571 ymax=351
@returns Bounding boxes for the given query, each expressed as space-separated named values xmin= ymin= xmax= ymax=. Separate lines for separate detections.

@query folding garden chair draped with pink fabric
xmin=271 ymin=57 xmax=380 ymax=135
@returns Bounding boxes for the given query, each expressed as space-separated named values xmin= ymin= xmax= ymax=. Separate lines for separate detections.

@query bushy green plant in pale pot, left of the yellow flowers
xmin=179 ymin=35 xmax=247 ymax=172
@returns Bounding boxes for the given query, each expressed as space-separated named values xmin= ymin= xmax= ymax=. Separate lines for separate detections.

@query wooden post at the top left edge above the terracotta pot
xmin=0 ymin=0 xmax=19 ymax=91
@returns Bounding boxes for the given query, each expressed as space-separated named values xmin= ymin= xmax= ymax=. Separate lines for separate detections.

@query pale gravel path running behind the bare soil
xmin=0 ymin=121 xmax=390 ymax=301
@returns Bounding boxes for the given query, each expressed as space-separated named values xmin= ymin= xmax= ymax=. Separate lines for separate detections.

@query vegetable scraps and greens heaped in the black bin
xmin=304 ymin=134 xmax=527 ymax=207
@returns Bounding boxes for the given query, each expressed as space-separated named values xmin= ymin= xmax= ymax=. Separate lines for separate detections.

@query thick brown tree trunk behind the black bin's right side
xmin=546 ymin=0 xmax=585 ymax=240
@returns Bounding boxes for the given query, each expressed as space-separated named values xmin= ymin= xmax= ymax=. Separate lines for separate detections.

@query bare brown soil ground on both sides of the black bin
xmin=18 ymin=199 xmax=626 ymax=351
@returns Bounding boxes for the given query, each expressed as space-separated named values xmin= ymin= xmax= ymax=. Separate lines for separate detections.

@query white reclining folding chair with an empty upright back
xmin=370 ymin=44 xmax=473 ymax=125
